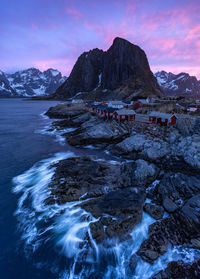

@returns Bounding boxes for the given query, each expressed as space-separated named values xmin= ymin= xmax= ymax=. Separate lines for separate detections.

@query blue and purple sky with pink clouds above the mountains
xmin=0 ymin=0 xmax=200 ymax=79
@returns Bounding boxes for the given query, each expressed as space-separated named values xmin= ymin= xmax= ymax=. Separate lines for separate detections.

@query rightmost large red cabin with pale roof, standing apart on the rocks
xmin=149 ymin=111 xmax=177 ymax=126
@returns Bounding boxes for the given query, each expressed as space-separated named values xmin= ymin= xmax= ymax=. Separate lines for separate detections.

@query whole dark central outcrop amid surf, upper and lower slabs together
xmin=46 ymin=157 xmax=161 ymax=243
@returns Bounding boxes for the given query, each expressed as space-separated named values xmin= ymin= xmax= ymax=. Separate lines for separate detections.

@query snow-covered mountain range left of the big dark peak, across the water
xmin=0 ymin=68 xmax=66 ymax=97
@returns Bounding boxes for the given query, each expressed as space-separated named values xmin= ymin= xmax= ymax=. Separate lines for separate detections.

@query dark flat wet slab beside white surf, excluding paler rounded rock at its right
xmin=49 ymin=157 xmax=121 ymax=203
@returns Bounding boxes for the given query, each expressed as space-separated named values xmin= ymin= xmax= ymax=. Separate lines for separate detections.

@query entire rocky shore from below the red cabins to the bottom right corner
xmin=46 ymin=105 xmax=200 ymax=279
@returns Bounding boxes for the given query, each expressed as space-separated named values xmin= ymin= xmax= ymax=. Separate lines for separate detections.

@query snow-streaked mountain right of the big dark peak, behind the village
xmin=155 ymin=71 xmax=200 ymax=97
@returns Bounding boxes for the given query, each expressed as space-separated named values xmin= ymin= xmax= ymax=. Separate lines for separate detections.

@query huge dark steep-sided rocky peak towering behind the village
xmin=54 ymin=38 xmax=162 ymax=100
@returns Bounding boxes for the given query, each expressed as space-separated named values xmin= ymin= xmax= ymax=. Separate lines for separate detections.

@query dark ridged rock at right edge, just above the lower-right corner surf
xmin=138 ymin=194 xmax=200 ymax=262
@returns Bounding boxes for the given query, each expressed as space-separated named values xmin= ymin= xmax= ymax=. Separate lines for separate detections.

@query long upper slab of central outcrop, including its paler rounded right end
xmin=49 ymin=157 xmax=156 ymax=207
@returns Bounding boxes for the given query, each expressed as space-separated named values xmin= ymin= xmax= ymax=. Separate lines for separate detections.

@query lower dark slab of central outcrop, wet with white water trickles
xmin=81 ymin=187 xmax=145 ymax=243
